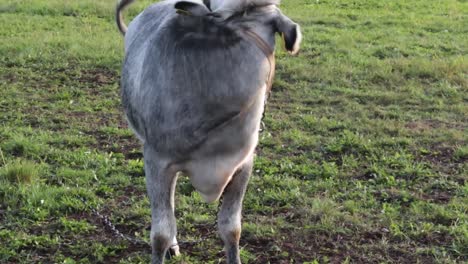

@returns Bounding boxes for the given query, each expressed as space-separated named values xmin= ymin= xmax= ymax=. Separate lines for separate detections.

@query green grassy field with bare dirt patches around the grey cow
xmin=0 ymin=0 xmax=468 ymax=263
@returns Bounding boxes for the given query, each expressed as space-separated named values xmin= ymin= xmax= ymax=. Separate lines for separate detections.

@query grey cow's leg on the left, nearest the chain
xmin=144 ymin=145 xmax=177 ymax=264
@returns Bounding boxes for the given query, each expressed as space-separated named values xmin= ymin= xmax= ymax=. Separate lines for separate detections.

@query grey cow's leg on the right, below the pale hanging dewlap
xmin=218 ymin=154 xmax=253 ymax=264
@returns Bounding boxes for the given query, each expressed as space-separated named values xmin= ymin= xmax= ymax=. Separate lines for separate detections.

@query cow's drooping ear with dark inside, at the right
xmin=275 ymin=12 xmax=302 ymax=55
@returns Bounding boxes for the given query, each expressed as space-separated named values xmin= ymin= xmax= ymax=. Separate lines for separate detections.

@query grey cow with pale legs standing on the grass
xmin=116 ymin=0 xmax=301 ymax=263
